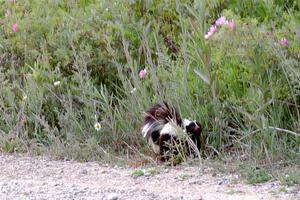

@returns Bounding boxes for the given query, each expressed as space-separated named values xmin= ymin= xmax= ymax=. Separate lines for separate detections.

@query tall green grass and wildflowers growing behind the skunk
xmin=0 ymin=0 xmax=300 ymax=183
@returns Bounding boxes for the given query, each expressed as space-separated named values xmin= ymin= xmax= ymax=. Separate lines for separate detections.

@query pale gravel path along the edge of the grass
xmin=0 ymin=154 xmax=300 ymax=200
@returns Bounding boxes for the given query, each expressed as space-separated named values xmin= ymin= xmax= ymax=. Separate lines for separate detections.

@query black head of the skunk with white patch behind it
xmin=183 ymin=119 xmax=202 ymax=150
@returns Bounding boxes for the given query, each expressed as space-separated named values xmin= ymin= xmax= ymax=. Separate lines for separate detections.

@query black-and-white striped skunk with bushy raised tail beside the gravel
xmin=142 ymin=101 xmax=202 ymax=161
